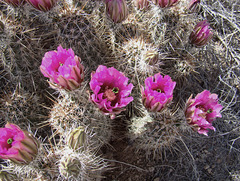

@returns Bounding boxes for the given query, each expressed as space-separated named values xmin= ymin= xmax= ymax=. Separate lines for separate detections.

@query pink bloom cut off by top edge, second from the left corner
xmin=27 ymin=0 xmax=58 ymax=12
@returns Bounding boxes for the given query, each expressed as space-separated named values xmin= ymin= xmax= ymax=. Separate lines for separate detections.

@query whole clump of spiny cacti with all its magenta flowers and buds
xmin=0 ymin=0 xmax=239 ymax=181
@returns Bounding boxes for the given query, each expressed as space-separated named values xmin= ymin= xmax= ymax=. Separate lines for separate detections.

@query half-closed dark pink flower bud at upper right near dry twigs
xmin=189 ymin=20 xmax=213 ymax=47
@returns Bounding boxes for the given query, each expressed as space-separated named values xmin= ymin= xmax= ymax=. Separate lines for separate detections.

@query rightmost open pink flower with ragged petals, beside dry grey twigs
xmin=185 ymin=90 xmax=223 ymax=136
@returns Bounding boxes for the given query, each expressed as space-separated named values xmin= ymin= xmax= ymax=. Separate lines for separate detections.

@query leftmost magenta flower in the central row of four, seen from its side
xmin=40 ymin=45 xmax=84 ymax=90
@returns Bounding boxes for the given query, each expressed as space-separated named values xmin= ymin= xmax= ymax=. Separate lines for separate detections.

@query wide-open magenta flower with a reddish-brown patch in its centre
xmin=90 ymin=65 xmax=133 ymax=119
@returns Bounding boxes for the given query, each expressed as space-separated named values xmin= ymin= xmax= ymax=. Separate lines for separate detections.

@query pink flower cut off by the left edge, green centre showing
xmin=0 ymin=123 xmax=39 ymax=164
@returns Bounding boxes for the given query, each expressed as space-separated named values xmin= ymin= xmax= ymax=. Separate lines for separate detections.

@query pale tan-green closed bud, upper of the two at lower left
xmin=68 ymin=126 xmax=86 ymax=150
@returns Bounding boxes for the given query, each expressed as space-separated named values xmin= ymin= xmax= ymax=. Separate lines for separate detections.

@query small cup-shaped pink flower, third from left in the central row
xmin=141 ymin=73 xmax=176 ymax=112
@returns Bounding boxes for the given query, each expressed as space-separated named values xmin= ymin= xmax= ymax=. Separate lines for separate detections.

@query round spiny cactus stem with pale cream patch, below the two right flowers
xmin=128 ymin=110 xmax=181 ymax=160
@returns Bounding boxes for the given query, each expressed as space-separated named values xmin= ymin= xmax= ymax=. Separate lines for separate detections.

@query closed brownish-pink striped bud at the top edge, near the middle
xmin=105 ymin=0 xmax=128 ymax=23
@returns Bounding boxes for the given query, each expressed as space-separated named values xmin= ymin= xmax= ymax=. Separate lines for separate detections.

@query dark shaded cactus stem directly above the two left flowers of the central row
xmin=56 ymin=12 xmax=108 ymax=70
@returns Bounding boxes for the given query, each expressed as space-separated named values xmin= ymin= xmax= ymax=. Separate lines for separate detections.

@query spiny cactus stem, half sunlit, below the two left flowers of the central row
xmin=47 ymin=90 xmax=112 ymax=150
